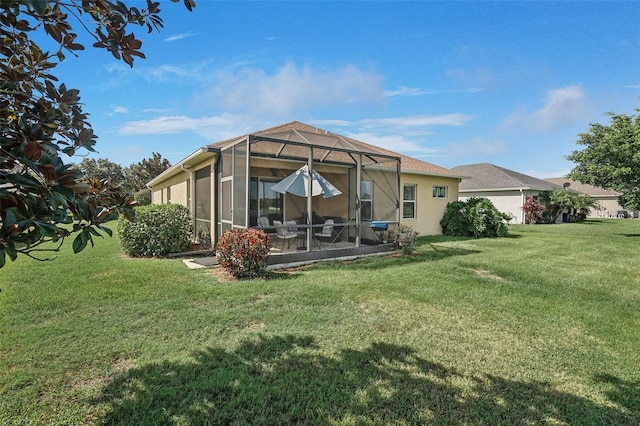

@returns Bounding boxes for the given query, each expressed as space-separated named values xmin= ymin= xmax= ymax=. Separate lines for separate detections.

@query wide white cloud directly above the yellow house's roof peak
xmin=206 ymin=63 xmax=384 ymax=117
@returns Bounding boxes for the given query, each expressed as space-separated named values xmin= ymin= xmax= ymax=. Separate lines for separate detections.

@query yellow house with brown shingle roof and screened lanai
xmin=148 ymin=121 xmax=462 ymax=258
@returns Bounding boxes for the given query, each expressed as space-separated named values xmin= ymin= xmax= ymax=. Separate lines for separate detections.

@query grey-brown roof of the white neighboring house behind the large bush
xmin=452 ymin=163 xmax=563 ymax=192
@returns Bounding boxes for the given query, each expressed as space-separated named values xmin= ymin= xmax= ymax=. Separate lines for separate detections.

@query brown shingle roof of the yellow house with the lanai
xmin=210 ymin=121 xmax=464 ymax=178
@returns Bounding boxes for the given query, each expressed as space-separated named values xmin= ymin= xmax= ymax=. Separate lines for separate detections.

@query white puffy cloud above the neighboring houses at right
xmin=500 ymin=86 xmax=589 ymax=133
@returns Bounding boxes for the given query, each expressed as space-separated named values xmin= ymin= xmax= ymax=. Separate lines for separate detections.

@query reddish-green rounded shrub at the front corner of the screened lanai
xmin=216 ymin=228 xmax=271 ymax=278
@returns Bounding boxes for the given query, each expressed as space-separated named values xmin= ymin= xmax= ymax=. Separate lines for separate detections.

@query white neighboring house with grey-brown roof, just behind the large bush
xmin=452 ymin=163 xmax=564 ymax=223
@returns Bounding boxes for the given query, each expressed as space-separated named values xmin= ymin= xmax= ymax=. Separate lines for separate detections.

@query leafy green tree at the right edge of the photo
xmin=567 ymin=109 xmax=640 ymax=210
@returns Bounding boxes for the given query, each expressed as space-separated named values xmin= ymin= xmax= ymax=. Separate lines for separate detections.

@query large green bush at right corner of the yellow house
xmin=440 ymin=197 xmax=511 ymax=238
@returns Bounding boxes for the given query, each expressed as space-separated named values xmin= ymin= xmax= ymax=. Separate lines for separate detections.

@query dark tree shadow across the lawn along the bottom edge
xmin=91 ymin=336 xmax=640 ymax=425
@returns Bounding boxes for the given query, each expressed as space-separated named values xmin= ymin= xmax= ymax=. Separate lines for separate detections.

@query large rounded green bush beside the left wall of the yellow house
xmin=118 ymin=204 xmax=193 ymax=257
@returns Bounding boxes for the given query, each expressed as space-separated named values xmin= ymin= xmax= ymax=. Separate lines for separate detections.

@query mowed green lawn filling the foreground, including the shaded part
xmin=0 ymin=220 xmax=640 ymax=425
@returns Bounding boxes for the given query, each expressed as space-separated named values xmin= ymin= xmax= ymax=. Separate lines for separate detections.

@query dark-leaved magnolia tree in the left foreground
xmin=0 ymin=0 xmax=195 ymax=267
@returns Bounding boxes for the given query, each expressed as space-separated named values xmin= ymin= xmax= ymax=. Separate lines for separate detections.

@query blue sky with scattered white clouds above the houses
xmin=42 ymin=0 xmax=640 ymax=178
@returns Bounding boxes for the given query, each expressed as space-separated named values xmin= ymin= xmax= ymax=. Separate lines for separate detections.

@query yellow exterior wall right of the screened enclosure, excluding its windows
xmin=400 ymin=173 xmax=459 ymax=235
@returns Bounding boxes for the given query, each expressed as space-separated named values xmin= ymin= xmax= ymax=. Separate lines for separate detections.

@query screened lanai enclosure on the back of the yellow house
xmin=215 ymin=127 xmax=400 ymax=252
